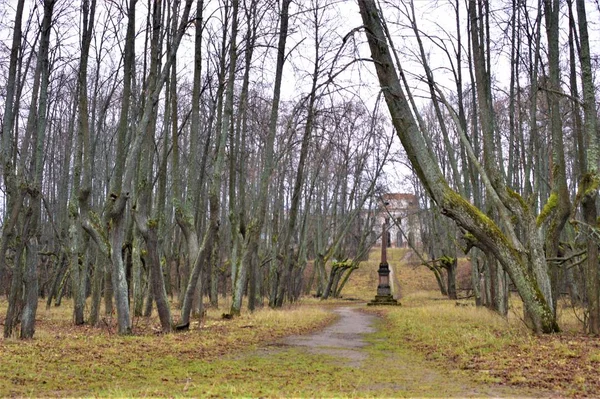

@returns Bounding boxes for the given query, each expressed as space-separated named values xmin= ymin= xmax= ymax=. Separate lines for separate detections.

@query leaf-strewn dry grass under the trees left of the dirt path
xmin=0 ymin=303 xmax=333 ymax=397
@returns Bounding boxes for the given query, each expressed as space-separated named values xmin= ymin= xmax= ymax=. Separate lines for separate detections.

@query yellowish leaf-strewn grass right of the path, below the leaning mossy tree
xmin=364 ymin=292 xmax=600 ymax=397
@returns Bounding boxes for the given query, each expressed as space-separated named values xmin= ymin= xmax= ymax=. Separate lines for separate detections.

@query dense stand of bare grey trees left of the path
xmin=0 ymin=0 xmax=391 ymax=338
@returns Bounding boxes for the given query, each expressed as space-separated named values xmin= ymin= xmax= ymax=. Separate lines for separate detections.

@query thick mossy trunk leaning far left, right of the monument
xmin=359 ymin=0 xmax=558 ymax=333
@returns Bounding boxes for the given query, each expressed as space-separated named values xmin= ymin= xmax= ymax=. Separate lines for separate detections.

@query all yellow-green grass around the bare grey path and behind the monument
xmin=0 ymin=249 xmax=600 ymax=397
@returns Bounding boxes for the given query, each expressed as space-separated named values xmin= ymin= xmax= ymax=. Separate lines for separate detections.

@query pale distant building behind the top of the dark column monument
xmin=375 ymin=193 xmax=421 ymax=248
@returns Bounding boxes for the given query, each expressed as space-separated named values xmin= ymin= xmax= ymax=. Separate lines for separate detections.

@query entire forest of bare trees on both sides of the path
xmin=0 ymin=0 xmax=600 ymax=338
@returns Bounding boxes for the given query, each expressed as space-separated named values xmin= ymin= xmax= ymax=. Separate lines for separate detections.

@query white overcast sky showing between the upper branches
xmin=0 ymin=0 xmax=600 ymax=197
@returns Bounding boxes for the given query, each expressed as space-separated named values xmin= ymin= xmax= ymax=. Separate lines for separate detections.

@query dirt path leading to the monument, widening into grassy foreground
xmin=255 ymin=307 xmax=535 ymax=397
